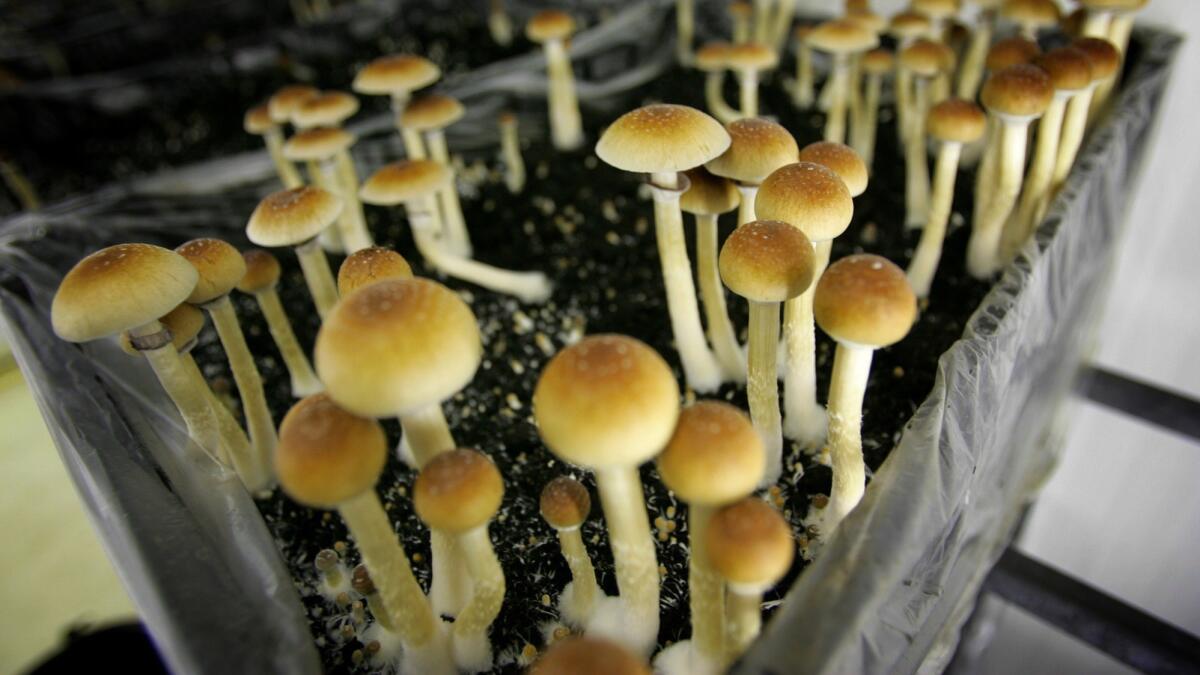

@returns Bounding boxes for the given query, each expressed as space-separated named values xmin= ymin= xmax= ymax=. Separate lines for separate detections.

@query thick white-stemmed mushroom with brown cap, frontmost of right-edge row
xmin=967 ymin=60 xmax=1054 ymax=279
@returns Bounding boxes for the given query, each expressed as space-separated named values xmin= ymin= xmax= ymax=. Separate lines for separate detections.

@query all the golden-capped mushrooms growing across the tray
xmin=52 ymin=0 xmax=1142 ymax=674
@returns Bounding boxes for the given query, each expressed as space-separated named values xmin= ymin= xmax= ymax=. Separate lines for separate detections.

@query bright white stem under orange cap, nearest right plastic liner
xmin=821 ymin=341 xmax=875 ymax=537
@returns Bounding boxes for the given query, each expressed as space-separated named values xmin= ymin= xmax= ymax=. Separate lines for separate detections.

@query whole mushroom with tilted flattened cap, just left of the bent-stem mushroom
xmin=246 ymin=186 xmax=342 ymax=318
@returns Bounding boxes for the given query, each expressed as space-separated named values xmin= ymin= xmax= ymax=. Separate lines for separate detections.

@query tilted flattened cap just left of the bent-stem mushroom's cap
xmin=246 ymin=185 xmax=342 ymax=246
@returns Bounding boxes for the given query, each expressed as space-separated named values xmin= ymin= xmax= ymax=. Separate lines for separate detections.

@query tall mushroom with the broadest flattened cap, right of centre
xmin=595 ymin=103 xmax=730 ymax=392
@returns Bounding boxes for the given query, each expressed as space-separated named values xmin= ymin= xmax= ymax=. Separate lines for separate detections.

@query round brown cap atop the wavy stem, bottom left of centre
xmin=413 ymin=448 xmax=504 ymax=534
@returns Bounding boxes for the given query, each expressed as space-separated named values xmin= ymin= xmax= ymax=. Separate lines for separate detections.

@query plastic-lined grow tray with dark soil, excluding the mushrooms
xmin=0 ymin=2 xmax=1178 ymax=673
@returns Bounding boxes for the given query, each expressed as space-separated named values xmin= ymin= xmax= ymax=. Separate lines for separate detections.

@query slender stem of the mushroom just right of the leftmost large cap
xmin=204 ymin=294 xmax=278 ymax=492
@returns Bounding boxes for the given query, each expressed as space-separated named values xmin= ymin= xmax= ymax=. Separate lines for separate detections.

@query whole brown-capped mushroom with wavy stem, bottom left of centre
xmin=413 ymin=449 xmax=504 ymax=673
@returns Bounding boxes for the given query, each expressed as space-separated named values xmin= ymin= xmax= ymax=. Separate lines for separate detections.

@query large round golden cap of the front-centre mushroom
xmin=533 ymin=335 xmax=679 ymax=468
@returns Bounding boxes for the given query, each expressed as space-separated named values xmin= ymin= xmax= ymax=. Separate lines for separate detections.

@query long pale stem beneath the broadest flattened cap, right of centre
xmin=650 ymin=173 xmax=721 ymax=392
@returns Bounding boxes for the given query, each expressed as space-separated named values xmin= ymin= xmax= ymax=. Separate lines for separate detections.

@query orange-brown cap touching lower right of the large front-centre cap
xmin=658 ymin=398 xmax=758 ymax=506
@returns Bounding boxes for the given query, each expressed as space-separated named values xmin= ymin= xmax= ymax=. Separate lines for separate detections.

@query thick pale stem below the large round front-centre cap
xmin=595 ymin=466 xmax=659 ymax=655
